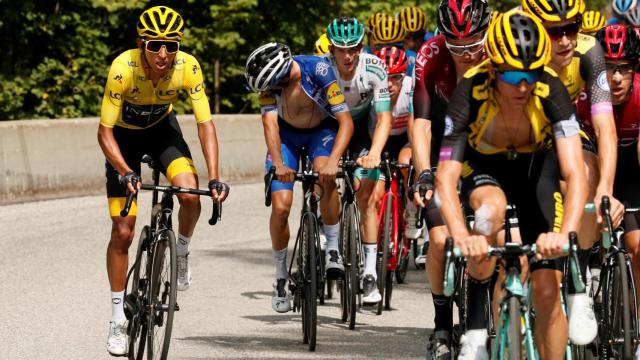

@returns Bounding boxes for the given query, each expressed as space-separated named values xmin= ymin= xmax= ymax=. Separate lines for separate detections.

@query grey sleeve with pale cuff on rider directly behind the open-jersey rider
xmin=580 ymin=38 xmax=613 ymax=115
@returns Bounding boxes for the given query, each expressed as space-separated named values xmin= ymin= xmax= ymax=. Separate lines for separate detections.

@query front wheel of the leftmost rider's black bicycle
xmin=147 ymin=230 xmax=178 ymax=360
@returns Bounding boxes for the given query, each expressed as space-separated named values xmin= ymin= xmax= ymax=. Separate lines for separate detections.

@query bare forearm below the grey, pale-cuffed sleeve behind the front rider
xmin=593 ymin=113 xmax=618 ymax=194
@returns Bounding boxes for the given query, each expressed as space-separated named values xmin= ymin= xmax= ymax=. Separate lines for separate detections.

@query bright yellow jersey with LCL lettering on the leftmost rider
xmin=100 ymin=49 xmax=211 ymax=129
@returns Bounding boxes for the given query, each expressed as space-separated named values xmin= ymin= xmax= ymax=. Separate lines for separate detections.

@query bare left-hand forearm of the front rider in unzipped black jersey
xmin=436 ymin=161 xmax=469 ymax=238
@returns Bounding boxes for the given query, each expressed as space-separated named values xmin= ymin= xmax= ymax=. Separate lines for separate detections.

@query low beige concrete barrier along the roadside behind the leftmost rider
xmin=0 ymin=115 xmax=266 ymax=204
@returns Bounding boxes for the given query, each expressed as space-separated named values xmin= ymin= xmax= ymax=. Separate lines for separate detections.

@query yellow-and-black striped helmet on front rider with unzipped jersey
xmin=485 ymin=9 xmax=551 ymax=70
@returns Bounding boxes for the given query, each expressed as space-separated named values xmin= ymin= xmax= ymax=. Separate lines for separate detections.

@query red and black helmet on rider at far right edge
xmin=596 ymin=24 xmax=638 ymax=60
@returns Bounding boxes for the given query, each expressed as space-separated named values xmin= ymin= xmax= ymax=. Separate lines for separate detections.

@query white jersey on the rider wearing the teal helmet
xmin=324 ymin=53 xmax=391 ymax=121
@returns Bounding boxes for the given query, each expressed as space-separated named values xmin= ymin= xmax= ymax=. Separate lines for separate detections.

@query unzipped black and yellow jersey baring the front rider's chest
xmin=440 ymin=60 xmax=579 ymax=162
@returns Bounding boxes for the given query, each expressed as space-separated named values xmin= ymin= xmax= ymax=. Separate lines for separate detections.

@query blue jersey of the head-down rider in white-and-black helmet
xmin=260 ymin=55 xmax=349 ymax=119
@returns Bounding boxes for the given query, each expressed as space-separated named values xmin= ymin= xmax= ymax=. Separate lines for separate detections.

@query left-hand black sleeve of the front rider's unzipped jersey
xmin=440 ymin=77 xmax=473 ymax=162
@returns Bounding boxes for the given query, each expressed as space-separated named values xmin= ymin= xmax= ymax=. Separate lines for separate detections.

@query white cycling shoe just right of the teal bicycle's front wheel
xmin=567 ymin=293 xmax=598 ymax=345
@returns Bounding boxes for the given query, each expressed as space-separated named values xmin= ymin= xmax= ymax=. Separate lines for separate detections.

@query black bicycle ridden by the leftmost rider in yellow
xmin=120 ymin=155 xmax=222 ymax=360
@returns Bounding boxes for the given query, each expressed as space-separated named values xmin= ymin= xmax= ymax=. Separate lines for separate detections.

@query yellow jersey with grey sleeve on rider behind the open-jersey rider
xmin=558 ymin=34 xmax=611 ymax=115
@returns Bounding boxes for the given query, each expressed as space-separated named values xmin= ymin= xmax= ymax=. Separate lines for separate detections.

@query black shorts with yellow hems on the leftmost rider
xmin=105 ymin=112 xmax=197 ymax=216
